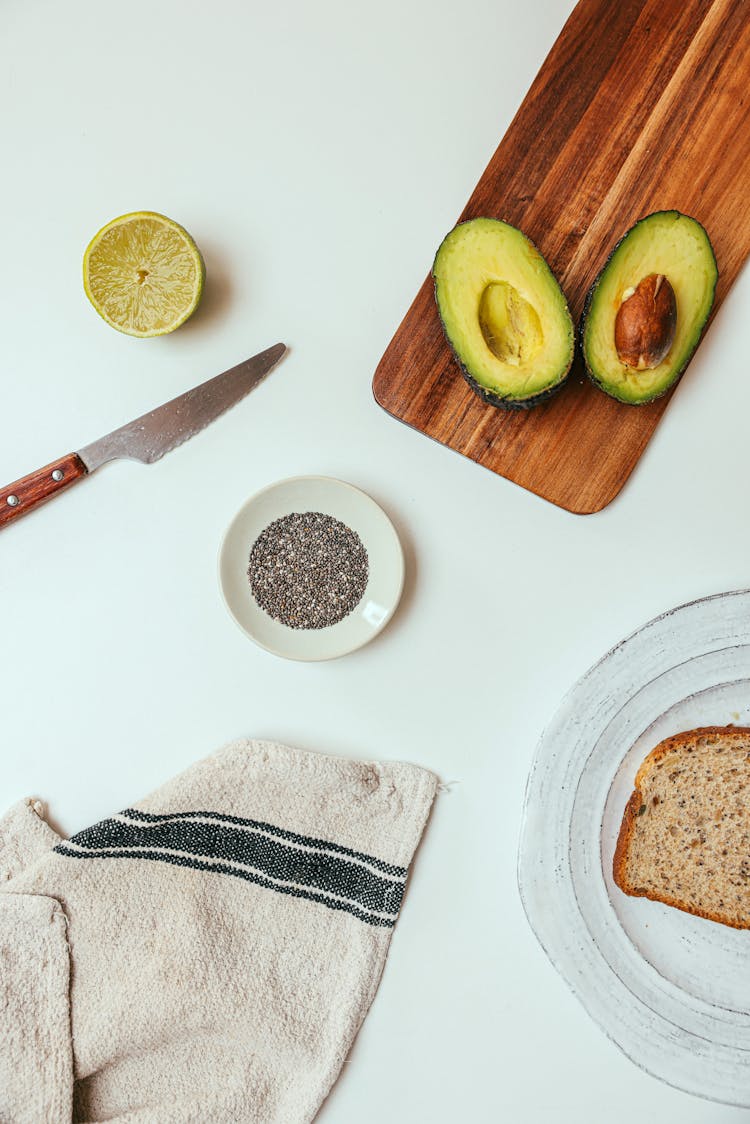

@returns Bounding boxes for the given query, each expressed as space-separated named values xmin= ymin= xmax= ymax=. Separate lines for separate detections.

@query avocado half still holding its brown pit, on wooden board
xmin=580 ymin=210 xmax=719 ymax=406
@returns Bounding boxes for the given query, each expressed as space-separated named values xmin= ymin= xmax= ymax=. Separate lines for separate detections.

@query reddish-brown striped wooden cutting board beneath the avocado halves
xmin=373 ymin=0 xmax=750 ymax=515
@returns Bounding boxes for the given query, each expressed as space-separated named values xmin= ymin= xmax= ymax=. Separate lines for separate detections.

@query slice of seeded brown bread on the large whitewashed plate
xmin=613 ymin=726 xmax=750 ymax=928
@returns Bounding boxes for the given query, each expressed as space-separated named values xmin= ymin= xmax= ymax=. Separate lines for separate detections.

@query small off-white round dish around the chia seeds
xmin=219 ymin=477 xmax=404 ymax=660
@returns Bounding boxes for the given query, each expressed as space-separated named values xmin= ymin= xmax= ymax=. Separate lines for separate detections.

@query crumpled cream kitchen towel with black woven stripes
xmin=0 ymin=742 xmax=437 ymax=1124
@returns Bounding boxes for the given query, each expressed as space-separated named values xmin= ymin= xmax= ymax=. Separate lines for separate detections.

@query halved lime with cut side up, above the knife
xmin=83 ymin=211 xmax=206 ymax=336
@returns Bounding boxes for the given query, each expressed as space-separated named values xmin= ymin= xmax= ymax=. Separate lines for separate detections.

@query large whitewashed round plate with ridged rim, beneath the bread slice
xmin=518 ymin=590 xmax=750 ymax=1106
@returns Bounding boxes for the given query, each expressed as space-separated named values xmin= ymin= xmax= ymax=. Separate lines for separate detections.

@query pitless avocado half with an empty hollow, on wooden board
xmin=432 ymin=218 xmax=575 ymax=410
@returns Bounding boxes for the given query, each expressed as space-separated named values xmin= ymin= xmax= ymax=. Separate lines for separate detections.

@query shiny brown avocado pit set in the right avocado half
xmin=614 ymin=273 xmax=677 ymax=371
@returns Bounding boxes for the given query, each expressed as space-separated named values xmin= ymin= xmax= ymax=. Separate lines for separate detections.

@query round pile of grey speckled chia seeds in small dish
xmin=247 ymin=511 xmax=369 ymax=628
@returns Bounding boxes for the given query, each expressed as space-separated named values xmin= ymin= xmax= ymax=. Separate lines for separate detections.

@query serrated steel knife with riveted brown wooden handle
xmin=0 ymin=344 xmax=287 ymax=527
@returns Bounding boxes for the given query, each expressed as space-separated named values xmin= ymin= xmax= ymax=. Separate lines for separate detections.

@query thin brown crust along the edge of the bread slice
xmin=612 ymin=726 xmax=750 ymax=930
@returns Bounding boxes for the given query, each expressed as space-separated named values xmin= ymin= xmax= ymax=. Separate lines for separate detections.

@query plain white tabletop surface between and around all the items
xmin=0 ymin=0 xmax=750 ymax=1124
